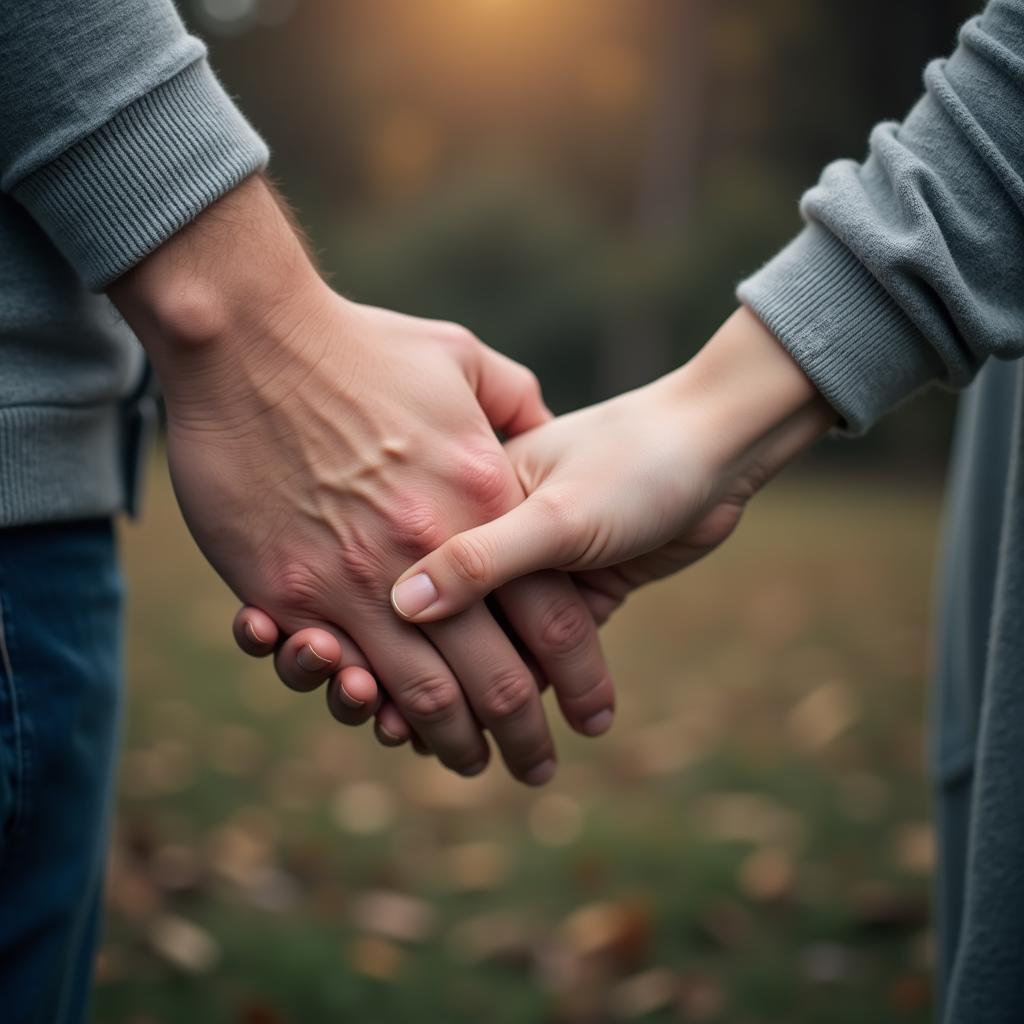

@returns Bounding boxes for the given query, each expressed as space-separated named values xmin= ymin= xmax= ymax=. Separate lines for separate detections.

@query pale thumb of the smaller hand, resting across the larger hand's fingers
xmin=391 ymin=496 xmax=572 ymax=623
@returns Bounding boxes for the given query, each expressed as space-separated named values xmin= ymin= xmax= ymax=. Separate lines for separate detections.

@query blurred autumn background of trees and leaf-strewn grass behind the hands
xmin=96 ymin=0 xmax=976 ymax=1024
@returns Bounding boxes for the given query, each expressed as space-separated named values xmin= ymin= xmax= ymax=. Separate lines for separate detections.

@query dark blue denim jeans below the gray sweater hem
xmin=0 ymin=520 xmax=123 ymax=1024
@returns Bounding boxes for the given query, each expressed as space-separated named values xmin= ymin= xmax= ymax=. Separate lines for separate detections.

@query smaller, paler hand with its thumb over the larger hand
xmin=234 ymin=307 xmax=836 ymax=749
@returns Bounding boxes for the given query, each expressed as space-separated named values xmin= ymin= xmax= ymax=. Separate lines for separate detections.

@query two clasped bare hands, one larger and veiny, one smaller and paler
xmin=111 ymin=179 xmax=830 ymax=785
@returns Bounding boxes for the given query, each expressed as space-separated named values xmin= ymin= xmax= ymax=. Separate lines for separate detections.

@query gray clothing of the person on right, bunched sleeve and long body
xmin=739 ymin=0 xmax=1024 ymax=1024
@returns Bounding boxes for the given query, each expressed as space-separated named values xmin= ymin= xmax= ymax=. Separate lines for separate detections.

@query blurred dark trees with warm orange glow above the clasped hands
xmin=186 ymin=0 xmax=980 ymax=468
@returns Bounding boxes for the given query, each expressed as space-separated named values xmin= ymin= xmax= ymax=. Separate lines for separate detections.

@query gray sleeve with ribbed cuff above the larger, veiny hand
xmin=0 ymin=0 xmax=267 ymax=290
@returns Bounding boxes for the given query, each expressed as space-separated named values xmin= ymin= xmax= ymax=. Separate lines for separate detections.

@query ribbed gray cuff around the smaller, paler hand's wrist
xmin=736 ymin=223 xmax=939 ymax=434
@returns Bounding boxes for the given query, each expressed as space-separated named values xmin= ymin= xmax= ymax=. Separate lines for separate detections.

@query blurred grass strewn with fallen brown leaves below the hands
xmin=95 ymin=458 xmax=938 ymax=1024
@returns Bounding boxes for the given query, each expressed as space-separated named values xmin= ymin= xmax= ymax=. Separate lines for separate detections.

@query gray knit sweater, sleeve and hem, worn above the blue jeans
xmin=0 ymin=0 xmax=266 ymax=526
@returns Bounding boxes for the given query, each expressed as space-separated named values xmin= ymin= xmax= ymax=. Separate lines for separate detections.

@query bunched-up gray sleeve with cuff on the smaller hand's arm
xmin=737 ymin=0 xmax=1024 ymax=432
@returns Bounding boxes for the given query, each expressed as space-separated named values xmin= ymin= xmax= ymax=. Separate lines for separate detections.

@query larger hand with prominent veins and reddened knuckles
xmin=111 ymin=179 xmax=613 ymax=783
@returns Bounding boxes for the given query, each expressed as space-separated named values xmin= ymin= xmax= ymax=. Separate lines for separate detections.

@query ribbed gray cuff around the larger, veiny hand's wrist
xmin=13 ymin=59 xmax=267 ymax=291
